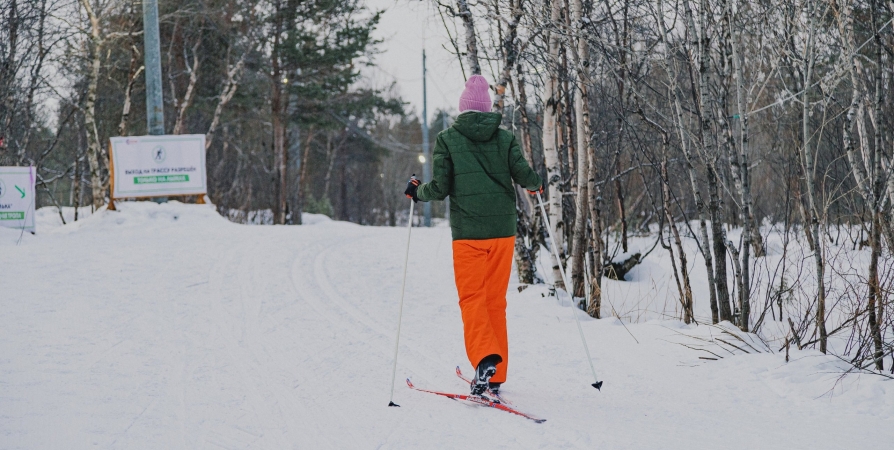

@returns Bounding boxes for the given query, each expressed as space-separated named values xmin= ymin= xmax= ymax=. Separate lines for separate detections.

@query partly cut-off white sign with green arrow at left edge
xmin=0 ymin=167 xmax=35 ymax=233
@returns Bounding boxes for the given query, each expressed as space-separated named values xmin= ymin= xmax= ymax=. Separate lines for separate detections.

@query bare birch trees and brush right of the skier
xmin=438 ymin=0 xmax=894 ymax=371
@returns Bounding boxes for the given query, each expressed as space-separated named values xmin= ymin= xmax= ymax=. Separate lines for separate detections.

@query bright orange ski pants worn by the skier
xmin=453 ymin=236 xmax=515 ymax=383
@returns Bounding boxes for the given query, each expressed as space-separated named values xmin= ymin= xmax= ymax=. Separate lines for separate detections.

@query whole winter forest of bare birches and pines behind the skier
xmin=0 ymin=0 xmax=894 ymax=376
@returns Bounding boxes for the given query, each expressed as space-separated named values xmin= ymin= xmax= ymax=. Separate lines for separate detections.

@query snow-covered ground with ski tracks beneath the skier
xmin=0 ymin=202 xmax=894 ymax=449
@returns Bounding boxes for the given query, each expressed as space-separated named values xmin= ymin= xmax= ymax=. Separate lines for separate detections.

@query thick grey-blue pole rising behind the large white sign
xmin=143 ymin=0 xmax=165 ymax=135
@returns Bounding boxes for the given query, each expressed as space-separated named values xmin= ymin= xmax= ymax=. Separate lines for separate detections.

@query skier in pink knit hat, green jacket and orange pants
xmin=404 ymin=75 xmax=543 ymax=395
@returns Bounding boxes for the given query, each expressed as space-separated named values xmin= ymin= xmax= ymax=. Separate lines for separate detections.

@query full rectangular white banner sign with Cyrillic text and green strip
xmin=111 ymin=134 xmax=208 ymax=198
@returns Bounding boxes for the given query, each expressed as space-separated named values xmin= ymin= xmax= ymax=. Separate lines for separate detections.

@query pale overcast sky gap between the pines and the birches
xmin=366 ymin=0 xmax=465 ymax=118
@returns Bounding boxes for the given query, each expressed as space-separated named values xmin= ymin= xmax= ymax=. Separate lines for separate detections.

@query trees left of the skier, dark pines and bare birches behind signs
xmin=0 ymin=0 xmax=412 ymax=224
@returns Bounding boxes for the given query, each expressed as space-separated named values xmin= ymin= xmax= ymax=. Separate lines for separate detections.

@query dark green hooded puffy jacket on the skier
xmin=416 ymin=111 xmax=542 ymax=240
